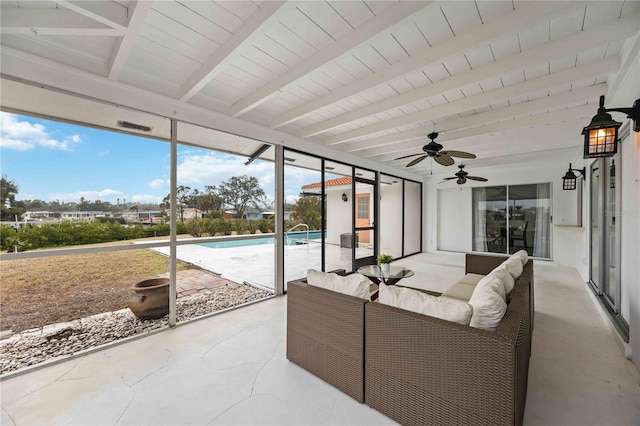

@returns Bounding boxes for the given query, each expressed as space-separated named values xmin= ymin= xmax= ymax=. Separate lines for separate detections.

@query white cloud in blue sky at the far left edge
xmin=0 ymin=112 xmax=82 ymax=151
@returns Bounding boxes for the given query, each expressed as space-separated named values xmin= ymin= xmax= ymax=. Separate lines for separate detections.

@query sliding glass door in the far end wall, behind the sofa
xmin=472 ymin=183 xmax=551 ymax=259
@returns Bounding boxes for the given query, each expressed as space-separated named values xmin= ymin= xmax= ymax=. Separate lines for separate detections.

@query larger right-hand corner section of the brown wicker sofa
xmin=365 ymin=254 xmax=534 ymax=425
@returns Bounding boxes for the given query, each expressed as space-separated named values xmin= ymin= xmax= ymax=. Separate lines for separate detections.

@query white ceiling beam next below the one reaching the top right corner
xmin=323 ymin=56 xmax=620 ymax=145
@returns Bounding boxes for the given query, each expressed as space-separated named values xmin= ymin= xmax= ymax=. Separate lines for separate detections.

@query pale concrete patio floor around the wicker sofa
xmin=0 ymin=254 xmax=640 ymax=425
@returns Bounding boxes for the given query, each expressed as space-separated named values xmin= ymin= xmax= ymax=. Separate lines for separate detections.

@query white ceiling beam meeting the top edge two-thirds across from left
xmin=230 ymin=1 xmax=434 ymax=117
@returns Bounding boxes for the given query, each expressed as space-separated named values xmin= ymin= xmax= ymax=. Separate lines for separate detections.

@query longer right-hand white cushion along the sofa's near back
xmin=378 ymin=283 xmax=473 ymax=325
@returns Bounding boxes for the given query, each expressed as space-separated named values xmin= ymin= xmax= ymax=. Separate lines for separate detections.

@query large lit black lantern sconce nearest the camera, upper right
xmin=582 ymin=96 xmax=640 ymax=158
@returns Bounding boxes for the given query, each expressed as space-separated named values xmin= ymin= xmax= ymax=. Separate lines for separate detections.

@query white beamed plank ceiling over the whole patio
xmin=1 ymin=0 xmax=640 ymax=175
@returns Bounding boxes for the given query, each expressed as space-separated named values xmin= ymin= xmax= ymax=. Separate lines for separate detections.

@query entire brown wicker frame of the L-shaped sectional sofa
xmin=287 ymin=254 xmax=534 ymax=425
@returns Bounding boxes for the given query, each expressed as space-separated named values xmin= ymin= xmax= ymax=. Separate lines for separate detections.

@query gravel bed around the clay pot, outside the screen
xmin=0 ymin=284 xmax=271 ymax=374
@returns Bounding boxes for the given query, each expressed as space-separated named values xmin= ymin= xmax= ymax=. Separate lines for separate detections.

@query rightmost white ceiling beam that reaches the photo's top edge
xmin=271 ymin=2 xmax=583 ymax=128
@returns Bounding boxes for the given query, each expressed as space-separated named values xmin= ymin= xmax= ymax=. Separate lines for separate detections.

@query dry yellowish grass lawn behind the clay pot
xmin=0 ymin=249 xmax=190 ymax=332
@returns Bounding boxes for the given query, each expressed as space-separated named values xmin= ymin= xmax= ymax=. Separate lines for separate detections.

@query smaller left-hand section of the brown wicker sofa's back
xmin=287 ymin=270 xmax=368 ymax=402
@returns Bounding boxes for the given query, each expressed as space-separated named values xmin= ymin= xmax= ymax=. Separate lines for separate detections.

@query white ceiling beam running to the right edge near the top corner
xmin=300 ymin=15 xmax=638 ymax=137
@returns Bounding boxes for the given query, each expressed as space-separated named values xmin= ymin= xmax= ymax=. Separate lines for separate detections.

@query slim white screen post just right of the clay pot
xmin=169 ymin=119 xmax=178 ymax=327
